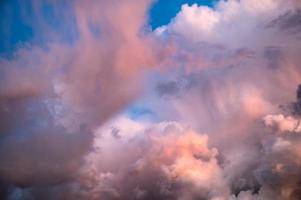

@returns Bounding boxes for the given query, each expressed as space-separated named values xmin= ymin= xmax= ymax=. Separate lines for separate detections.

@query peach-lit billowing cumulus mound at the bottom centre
xmin=68 ymin=118 xmax=229 ymax=199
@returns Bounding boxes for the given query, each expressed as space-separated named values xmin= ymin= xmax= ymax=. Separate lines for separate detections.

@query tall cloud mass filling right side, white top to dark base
xmin=146 ymin=0 xmax=300 ymax=199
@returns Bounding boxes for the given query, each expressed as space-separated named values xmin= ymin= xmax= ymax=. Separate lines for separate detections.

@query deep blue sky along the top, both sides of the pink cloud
xmin=0 ymin=0 xmax=215 ymax=56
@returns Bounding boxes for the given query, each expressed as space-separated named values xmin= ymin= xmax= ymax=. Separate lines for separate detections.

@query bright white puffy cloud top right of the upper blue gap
xmin=161 ymin=0 xmax=298 ymax=47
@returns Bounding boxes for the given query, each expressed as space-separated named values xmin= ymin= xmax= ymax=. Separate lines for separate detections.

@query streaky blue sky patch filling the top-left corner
xmin=0 ymin=0 xmax=78 ymax=57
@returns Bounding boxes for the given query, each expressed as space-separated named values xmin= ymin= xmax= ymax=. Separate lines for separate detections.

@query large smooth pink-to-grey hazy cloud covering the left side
xmin=0 ymin=1 xmax=154 ymax=199
